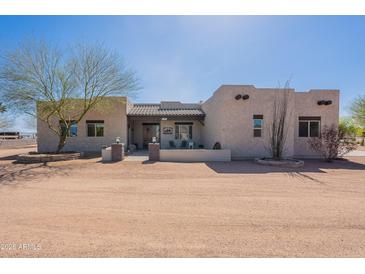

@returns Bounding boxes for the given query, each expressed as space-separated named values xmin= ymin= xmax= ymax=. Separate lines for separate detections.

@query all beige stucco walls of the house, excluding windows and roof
xmin=37 ymin=85 xmax=339 ymax=159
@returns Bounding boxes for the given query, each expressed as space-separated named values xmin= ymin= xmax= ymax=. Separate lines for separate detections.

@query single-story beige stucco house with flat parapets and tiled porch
xmin=37 ymin=85 xmax=339 ymax=159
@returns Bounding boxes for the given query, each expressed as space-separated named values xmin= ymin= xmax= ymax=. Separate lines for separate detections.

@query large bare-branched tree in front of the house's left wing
xmin=0 ymin=41 xmax=139 ymax=151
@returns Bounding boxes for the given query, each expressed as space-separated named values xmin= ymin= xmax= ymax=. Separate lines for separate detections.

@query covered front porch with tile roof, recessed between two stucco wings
xmin=127 ymin=101 xmax=205 ymax=150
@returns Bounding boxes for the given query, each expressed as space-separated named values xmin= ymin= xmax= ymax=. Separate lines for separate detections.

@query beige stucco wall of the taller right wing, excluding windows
xmin=202 ymin=85 xmax=338 ymax=159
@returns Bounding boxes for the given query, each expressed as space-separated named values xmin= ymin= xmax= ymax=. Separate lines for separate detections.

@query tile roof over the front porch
xmin=128 ymin=101 xmax=205 ymax=116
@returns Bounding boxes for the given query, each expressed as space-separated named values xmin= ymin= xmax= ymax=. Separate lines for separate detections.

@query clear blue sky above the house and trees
xmin=0 ymin=16 xmax=365 ymax=130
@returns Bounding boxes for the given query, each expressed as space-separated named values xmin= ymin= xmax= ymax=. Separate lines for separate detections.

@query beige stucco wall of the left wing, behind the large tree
xmin=37 ymin=97 xmax=127 ymax=152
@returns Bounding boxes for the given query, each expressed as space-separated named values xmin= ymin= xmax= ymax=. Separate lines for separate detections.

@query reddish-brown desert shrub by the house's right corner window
xmin=308 ymin=125 xmax=356 ymax=162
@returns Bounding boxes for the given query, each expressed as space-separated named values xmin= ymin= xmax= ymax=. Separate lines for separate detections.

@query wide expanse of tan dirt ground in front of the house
xmin=0 ymin=148 xmax=365 ymax=257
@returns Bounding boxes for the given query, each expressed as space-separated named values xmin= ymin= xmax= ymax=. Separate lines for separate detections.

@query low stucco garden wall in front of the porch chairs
xmin=160 ymin=149 xmax=231 ymax=162
